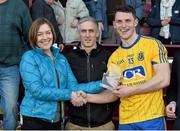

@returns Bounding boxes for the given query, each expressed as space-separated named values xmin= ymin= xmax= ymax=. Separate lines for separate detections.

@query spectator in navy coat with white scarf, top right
xmin=147 ymin=0 xmax=180 ymax=44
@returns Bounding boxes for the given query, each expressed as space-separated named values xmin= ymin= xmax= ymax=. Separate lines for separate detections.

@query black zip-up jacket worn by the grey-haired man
xmin=66 ymin=44 xmax=113 ymax=127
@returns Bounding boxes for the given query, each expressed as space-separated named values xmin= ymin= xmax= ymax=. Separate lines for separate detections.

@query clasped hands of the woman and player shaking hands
xmin=71 ymin=91 xmax=88 ymax=107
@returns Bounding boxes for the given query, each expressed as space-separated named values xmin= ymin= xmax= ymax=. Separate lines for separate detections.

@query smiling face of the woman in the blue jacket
xmin=37 ymin=24 xmax=53 ymax=51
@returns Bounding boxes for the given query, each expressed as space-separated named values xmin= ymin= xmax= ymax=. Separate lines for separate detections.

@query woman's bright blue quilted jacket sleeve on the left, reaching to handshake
xmin=20 ymin=52 xmax=71 ymax=101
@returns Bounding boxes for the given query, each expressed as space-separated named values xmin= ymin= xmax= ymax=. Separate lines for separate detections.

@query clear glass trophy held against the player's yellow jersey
xmin=101 ymin=63 xmax=122 ymax=91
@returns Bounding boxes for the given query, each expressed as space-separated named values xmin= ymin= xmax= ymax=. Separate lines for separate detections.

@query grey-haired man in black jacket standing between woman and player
xmin=66 ymin=17 xmax=115 ymax=130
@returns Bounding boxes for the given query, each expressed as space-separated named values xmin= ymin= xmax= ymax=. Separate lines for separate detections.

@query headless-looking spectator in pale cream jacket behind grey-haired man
xmin=51 ymin=0 xmax=89 ymax=43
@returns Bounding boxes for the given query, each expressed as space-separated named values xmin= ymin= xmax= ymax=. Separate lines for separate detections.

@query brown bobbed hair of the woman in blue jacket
xmin=29 ymin=17 xmax=56 ymax=48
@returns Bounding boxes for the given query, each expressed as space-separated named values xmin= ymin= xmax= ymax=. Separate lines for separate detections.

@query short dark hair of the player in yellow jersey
xmin=114 ymin=5 xmax=137 ymax=20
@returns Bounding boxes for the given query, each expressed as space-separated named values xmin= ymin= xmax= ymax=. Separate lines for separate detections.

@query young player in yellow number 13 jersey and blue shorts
xmin=108 ymin=6 xmax=170 ymax=130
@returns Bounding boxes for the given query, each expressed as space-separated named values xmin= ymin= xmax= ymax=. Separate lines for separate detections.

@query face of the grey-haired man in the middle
xmin=79 ymin=21 xmax=99 ymax=48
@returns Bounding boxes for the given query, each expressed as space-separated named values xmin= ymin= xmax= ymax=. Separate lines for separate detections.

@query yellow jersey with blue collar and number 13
xmin=108 ymin=35 xmax=167 ymax=124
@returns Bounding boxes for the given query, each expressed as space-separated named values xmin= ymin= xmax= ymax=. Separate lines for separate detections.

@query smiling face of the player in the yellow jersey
xmin=113 ymin=12 xmax=138 ymax=40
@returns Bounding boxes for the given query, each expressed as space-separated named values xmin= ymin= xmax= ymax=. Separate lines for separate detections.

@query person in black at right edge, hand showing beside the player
xmin=166 ymin=52 xmax=180 ymax=130
